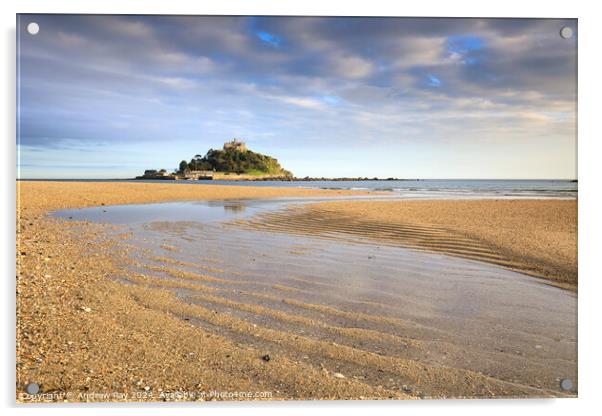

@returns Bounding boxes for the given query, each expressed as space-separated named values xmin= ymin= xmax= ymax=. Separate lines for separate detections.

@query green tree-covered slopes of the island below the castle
xmin=179 ymin=148 xmax=292 ymax=177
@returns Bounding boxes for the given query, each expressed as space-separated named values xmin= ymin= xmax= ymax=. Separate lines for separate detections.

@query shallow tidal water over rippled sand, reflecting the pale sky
xmin=55 ymin=200 xmax=577 ymax=394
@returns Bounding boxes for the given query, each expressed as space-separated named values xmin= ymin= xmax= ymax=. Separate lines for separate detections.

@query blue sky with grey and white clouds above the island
xmin=17 ymin=15 xmax=577 ymax=179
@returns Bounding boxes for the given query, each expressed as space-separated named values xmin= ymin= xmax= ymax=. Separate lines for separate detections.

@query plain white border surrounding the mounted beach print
xmin=0 ymin=0 xmax=602 ymax=416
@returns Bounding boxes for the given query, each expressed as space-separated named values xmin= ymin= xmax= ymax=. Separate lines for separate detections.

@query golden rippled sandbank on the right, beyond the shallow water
xmin=245 ymin=200 xmax=577 ymax=290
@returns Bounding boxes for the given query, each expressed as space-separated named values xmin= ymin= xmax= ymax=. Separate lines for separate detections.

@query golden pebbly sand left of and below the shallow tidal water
xmin=17 ymin=182 xmax=572 ymax=402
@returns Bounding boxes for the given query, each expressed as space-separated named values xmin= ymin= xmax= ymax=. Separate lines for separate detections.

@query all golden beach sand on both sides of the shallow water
xmin=17 ymin=181 xmax=577 ymax=402
